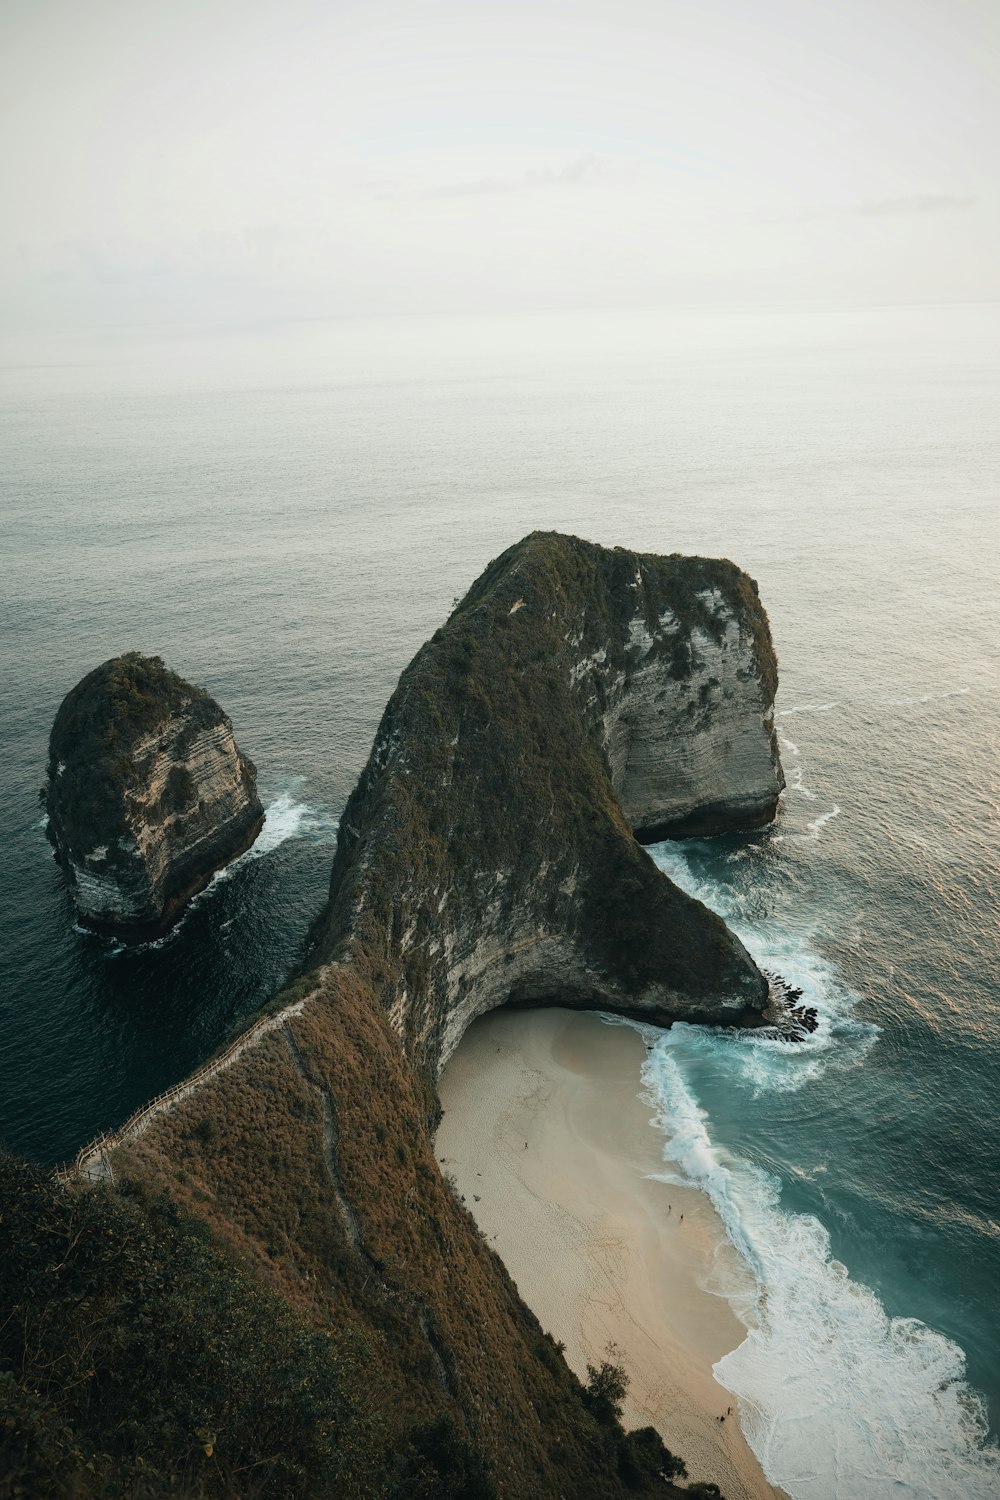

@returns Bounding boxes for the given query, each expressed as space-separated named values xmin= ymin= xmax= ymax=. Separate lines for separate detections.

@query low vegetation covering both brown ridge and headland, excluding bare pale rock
xmin=11 ymin=534 xmax=775 ymax=1500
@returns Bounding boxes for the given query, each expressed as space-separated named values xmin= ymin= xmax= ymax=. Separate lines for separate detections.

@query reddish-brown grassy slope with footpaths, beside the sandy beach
xmin=97 ymin=965 xmax=716 ymax=1500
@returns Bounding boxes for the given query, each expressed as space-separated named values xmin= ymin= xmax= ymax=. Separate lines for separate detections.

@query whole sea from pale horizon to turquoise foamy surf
xmin=0 ymin=305 xmax=1000 ymax=1500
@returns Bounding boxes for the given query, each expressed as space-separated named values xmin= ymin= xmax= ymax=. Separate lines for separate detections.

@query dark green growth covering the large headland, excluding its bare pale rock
xmin=310 ymin=533 xmax=777 ymax=1073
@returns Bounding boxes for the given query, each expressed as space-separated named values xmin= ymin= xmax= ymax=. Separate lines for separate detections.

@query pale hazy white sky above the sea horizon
xmin=0 ymin=0 xmax=1000 ymax=329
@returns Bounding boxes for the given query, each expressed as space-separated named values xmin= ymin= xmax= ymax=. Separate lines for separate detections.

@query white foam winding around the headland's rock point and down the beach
xmin=643 ymin=840 xmax=1000 ymax=1500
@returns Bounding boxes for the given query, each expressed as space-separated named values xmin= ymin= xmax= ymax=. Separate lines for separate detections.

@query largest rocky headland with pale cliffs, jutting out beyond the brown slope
xmin=310 ymin=533 xmax=784 ymax=1076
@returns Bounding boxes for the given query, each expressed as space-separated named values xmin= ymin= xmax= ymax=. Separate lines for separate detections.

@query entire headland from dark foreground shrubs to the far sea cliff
xmin=0 ymin=536 xmax=780 ymax=1500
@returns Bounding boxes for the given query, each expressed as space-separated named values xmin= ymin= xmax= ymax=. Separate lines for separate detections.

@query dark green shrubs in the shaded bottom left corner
xmin=0 ymin=1157 xmax=382 ymax=1500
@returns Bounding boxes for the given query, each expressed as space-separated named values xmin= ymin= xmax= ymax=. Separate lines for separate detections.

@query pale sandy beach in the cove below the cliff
xmin=438 ymin=1010 xmax=784 ymax=1500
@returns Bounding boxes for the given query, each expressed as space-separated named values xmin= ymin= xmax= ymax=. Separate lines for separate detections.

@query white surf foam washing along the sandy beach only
xmin=643 ymin=1044 xmax=1000 ymax=1500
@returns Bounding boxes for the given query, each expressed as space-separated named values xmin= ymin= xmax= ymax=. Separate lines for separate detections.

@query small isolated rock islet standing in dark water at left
xmin=45 ymin=651 xmax=264 ymax=939
